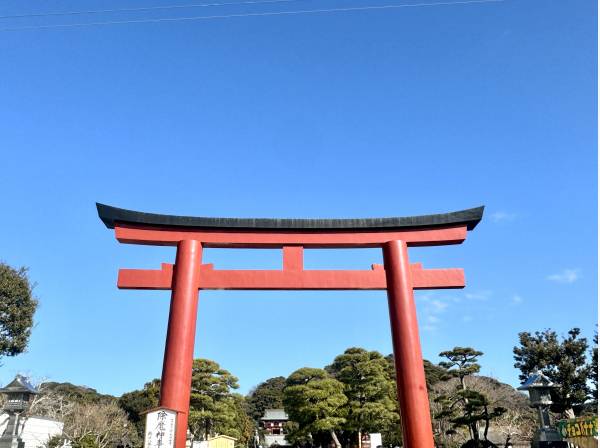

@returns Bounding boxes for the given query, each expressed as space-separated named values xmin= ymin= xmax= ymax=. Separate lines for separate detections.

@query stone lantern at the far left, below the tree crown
xmin=0 ymin=375 xmax=38 ymax=448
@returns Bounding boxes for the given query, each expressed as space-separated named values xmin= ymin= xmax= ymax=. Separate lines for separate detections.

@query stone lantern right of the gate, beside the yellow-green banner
xmin=517 ymin=370 xmax=568 ymax=448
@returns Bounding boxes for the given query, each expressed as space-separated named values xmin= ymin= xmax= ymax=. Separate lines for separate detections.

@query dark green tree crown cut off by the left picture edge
xmin=0 ymin=262 xmax=38 ymax=358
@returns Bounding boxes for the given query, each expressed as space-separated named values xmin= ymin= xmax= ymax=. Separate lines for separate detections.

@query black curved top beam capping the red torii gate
xmin=96 ymin=203 xmax=483 ymax=231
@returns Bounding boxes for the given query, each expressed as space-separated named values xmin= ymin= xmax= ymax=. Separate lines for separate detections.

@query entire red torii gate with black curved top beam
xmin=96 ymin=204 xmax=483 ymax=448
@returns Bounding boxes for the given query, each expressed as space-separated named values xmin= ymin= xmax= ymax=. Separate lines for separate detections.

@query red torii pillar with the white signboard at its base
xmin=160 ymin=240 xmax=202 ymax=448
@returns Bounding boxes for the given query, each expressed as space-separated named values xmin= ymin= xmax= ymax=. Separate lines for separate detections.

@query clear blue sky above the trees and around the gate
xmin=0 ymin=0 xmax=597 ymax=395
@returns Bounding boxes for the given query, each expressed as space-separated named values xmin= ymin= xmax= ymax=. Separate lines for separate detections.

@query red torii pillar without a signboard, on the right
xmin=383 ymin=241 xmax=434 ymax=448
